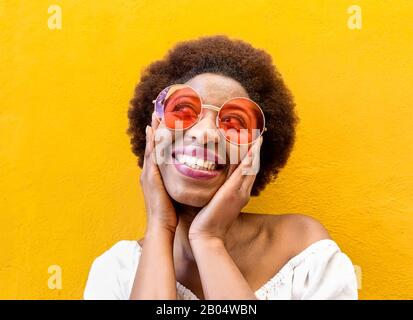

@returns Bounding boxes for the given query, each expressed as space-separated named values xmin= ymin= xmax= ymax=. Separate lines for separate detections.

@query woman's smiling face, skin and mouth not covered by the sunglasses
xmin=158 ymin=73 xmax=248 ymax=207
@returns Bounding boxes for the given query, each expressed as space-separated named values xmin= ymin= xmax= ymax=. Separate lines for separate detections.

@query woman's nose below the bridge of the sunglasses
xmin=184 ymin=109 xmax=220 ymax=145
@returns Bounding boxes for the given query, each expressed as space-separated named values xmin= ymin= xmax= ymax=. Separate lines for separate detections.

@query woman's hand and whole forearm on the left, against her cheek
xmin=129 ymin=114 xmax=178 ymax=300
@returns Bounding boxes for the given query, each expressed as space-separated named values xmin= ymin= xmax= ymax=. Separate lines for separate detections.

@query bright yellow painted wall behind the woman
xmin=0 ymin=0 xmax=413 ymax=299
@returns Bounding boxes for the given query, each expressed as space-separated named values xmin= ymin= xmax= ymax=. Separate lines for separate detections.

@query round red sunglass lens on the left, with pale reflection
xmin=157 ymin=85 xmax=201 ymax=129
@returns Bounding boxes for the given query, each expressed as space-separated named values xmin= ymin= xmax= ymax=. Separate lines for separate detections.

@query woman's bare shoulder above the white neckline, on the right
xmin=240 ymin=214 xmax=331 ymax=257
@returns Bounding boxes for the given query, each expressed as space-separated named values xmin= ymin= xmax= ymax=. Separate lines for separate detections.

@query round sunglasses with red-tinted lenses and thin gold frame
xmin=152 ymin=84 xmax=267 ymax=145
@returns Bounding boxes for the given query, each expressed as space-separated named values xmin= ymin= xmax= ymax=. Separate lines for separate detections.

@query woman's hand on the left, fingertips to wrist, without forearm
xmin=139 ymin=113 xmax=178 ymax=232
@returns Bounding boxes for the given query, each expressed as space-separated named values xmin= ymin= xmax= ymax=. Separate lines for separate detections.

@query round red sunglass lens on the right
xmin=218 ymin=98 xmax=264 ymax=144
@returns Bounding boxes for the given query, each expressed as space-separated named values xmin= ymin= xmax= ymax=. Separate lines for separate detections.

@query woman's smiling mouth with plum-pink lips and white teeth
xmin=172 ymin=146 xmax=225 ymax=179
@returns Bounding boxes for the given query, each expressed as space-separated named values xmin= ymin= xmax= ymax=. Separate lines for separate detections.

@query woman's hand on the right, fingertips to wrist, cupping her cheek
xmin=188 ymin=137 xmax=262 ymax=241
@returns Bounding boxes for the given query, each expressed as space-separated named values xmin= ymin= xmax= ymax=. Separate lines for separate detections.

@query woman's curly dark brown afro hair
xmin=127 ymin=35 xmax=298 ymax=196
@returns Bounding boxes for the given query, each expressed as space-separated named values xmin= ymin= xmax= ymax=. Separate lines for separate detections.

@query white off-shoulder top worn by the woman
xmin=83 ymin=239 xmax=358 ymax=300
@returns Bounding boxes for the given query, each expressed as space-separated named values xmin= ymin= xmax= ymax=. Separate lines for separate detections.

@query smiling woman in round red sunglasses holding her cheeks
xmin=84 ymin=35 xmax=357 ymax=299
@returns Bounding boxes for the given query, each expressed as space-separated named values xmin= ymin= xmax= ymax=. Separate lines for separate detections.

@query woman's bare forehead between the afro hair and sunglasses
xmin=185 ymin=73 xmax=249 ymax=105
